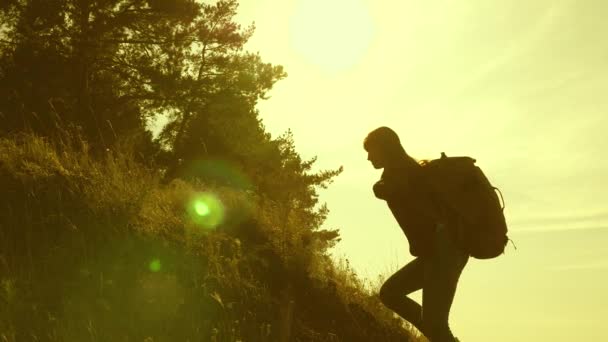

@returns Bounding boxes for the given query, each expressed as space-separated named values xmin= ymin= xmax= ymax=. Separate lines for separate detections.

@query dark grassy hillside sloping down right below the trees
xmin=0 ymin=134 xmax=414 ymax=342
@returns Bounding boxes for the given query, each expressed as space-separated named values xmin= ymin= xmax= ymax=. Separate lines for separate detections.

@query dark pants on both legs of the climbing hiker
xmin=380 ymin=225 xmax=469 ymax=342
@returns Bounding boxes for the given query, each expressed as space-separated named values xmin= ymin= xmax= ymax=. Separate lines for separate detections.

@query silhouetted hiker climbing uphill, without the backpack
xmin=363 ymin=127 xmax=469 ymax=342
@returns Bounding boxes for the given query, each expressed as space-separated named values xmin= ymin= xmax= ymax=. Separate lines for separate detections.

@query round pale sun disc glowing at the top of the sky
xmin=291 ymin=0 xmax=373 ymax=71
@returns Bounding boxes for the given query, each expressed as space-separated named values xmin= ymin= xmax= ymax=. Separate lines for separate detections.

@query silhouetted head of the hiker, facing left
xmin=363 ymin=126 xmax=405 ymax=169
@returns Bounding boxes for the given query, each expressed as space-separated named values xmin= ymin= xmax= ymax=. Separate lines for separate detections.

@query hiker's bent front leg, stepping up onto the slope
xmin=380 ymin=258 xmax=424 ymax=331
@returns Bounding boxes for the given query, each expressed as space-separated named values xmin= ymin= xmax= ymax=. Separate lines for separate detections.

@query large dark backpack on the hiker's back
xmin=421 ymin=153 xmax=509 ymax=259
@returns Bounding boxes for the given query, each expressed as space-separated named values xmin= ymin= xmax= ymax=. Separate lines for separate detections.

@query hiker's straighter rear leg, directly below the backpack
xmin=422 ymin=225 xmax=469 ymax=342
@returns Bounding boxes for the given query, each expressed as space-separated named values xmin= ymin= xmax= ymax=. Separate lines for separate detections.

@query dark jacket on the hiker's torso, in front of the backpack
xmin=374 ymin=160 xmax=441 ymax=256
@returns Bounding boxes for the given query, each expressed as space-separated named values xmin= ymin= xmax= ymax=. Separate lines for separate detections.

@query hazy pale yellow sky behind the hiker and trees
xmin=234 ymin=0 xmax=608 ymax=342
